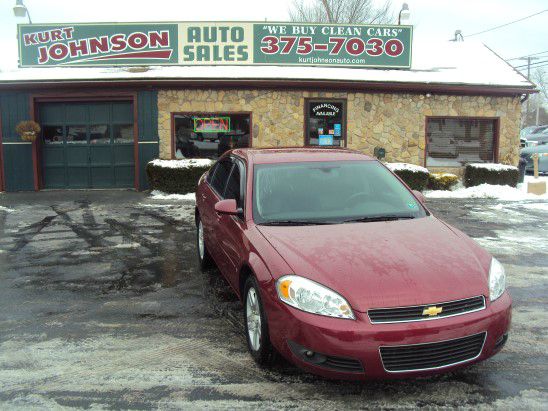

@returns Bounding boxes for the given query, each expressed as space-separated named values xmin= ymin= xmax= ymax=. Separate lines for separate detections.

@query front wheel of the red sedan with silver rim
xmin=244 ymin=276 xmax=275 ymax=366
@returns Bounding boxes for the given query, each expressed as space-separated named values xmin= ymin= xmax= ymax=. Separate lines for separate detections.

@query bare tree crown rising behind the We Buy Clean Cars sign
xmin=289 ymin=0 xmax=394 ymax=24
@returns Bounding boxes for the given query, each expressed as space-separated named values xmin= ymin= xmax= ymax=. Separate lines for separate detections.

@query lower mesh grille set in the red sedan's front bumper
xmin=380 ymin=332 xmax=487 ymax=372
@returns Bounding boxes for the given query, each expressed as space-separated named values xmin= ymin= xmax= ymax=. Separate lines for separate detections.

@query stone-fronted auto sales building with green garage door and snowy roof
xmin=0 ymin=22 xmax=535 ymax=191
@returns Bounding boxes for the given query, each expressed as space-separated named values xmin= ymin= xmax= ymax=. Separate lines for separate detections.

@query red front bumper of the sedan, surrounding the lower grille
xmin=267 ymin=292 xmax=512 ymax=379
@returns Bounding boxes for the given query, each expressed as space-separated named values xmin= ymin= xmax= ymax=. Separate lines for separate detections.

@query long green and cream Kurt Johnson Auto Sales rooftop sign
xmin=18 ymin=22 xmax=412 ymax=68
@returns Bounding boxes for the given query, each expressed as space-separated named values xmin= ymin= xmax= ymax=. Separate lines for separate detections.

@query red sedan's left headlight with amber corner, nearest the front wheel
xmin=276 ymin=275 xmax=354 ymax=320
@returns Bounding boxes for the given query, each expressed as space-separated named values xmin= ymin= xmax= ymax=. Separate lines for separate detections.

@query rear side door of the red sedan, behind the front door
xmin=199 ymin=158 xmax=233 ymax=273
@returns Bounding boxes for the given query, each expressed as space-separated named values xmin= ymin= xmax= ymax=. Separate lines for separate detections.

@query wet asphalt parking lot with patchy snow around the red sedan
xmin=0 ymin=191 xmax=548 ymax=409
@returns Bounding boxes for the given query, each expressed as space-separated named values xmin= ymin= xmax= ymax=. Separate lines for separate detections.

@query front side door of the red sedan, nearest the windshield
xmin=218 ymin=157 xmax=246 ymax=289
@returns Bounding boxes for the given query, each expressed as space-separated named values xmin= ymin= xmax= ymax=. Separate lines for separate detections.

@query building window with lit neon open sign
xmin=173 ymin=113 xmax=251 ymax=158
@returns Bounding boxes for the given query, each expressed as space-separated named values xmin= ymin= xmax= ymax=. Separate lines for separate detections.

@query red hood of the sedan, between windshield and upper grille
xmin=258 ymin=216 xmax=489 ymax=312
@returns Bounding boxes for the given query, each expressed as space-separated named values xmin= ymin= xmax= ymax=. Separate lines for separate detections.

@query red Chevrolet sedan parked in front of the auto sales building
xmin=196 ymin=148 xmax=512 ymax=379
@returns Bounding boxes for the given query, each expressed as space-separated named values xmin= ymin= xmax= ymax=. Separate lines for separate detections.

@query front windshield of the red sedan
xmin=253 ymin=161 xmax=426 ymax=225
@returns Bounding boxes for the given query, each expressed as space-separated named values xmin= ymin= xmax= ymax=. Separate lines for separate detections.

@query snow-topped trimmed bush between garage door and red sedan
xmin=146 ymin=159 xmax=213 ymax=194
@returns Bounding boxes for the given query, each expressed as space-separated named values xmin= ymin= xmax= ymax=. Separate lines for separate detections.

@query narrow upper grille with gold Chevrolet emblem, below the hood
xmin=367 ymin=295 xmax=485 ymax=324
